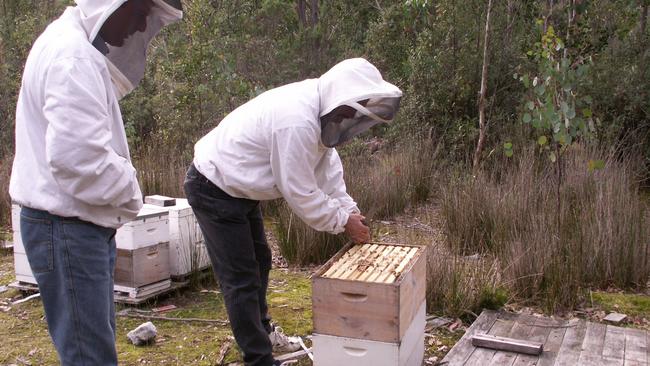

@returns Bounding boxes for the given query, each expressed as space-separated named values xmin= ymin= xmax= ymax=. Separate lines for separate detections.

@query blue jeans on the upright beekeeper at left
xmin=20 ymin=207 xmax=117 ymax=365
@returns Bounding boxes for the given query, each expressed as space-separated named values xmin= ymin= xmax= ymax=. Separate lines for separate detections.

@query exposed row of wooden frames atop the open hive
xmin=321 ymin=243 xmax=420 ymax=283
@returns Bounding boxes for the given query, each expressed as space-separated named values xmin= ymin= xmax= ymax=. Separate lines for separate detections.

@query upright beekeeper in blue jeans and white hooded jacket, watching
xmin=9 ymin=0 xmax=182 ymax=365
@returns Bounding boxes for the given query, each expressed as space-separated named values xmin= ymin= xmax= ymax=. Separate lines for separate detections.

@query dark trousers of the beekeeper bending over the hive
xmin=184 ymin=165 xmax=273 ymax=366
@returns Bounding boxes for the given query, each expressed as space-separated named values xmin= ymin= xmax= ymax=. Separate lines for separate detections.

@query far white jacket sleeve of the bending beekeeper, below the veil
xmin=316 ymin=148 xmax=361 ymax=214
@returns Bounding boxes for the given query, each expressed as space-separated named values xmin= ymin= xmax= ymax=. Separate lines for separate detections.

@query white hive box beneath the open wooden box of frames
xmin=312 ymin=302 xmax=426 ymax=366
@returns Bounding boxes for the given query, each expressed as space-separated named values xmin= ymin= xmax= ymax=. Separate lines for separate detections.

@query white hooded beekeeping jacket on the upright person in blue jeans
xmin=9 ymin=0 xmax=182 ymax=228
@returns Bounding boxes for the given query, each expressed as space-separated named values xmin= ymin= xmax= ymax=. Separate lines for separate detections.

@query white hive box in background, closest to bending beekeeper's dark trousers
xmin=144 ymin=196 xmax=210 ymax=278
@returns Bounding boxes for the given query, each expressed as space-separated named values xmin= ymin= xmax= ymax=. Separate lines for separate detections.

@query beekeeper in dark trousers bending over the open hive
xmin=185 ymin=58 xmax=402 ymax=366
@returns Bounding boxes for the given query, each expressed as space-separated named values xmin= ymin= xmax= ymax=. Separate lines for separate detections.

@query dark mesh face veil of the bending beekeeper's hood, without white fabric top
xmin=321 ymin=97 xmax=401 ymax=147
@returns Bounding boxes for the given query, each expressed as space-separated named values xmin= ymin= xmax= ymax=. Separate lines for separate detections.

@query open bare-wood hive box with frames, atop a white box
xmin=312 ymin=243 xmax=426 ymax=343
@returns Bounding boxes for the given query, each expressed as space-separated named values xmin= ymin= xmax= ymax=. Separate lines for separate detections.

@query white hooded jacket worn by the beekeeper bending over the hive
xmin=194 ymin=58 xmax=402 ymax=234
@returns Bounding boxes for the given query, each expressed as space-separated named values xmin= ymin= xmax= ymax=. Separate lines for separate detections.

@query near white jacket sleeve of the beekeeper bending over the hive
xmin=271 ymin=127 xmax=349 ymax=234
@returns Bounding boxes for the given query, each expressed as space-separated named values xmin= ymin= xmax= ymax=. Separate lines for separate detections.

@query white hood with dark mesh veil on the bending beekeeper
xmin=319 ymin=58 xmax=402 ymax=147
